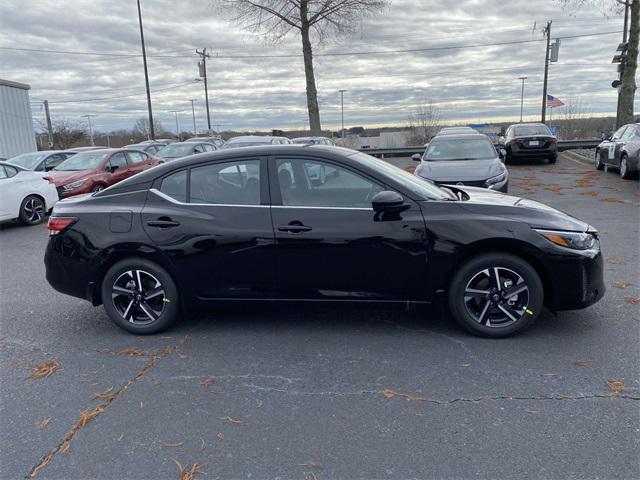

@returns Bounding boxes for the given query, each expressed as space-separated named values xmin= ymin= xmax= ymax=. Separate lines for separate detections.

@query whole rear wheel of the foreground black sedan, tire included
xmin=101 ymin=258 xmax=180 ymax=335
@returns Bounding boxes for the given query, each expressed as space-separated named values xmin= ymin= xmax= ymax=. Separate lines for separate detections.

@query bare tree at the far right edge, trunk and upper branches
xmin=556 ymin=0 xmax=640 ymax=125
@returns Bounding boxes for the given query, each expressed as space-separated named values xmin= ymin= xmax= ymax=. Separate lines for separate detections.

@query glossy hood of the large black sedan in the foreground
xmin=450 ymin=187 xmax=595 ymax=232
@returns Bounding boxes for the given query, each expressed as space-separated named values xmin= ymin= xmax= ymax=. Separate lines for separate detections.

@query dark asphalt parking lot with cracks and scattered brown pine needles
xmin=0 ymin=155 xmax=640 ymax=480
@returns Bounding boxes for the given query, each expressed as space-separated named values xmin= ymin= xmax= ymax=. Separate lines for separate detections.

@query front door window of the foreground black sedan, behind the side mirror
xmin=277 ymin=159 xmax=384 ymax=208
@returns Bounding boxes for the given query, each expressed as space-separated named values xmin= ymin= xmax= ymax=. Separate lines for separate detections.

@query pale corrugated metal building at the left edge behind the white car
xmin=0 ymin=79 xmax=38 ymax=158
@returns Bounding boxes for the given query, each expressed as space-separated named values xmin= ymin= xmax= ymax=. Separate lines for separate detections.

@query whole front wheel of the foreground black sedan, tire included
xmin=448 ymin=252 xmax=544 ymax=338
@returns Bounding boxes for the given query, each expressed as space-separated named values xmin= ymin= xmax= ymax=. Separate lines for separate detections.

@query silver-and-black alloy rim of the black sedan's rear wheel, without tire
xmin=111 ymin=270 xmax=166 ymax=325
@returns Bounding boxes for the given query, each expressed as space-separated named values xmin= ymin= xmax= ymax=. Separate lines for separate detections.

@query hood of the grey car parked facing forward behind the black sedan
xmin=415 ymin=158 xmax=505 ymax=183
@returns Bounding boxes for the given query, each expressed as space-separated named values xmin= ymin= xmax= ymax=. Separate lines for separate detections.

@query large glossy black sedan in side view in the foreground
xmin=45 ymin=145 xmax=605 ymax=337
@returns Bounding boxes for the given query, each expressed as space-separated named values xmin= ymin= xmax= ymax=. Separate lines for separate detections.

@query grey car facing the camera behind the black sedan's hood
xmin=411 ymin=133 xmax=509 ymax=193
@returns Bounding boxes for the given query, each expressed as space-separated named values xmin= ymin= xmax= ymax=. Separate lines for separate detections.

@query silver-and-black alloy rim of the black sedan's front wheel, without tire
xmin=464 ymin=267 xmax=529 ymax=327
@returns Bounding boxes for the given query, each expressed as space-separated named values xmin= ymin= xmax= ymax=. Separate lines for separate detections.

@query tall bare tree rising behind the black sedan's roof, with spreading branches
xmin=215 ymin=0 xmax=388 ymax=135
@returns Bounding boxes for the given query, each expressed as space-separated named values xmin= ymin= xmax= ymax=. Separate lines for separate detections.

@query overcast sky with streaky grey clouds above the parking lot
xmin=0 ymin=0 xmax=622 ymax=131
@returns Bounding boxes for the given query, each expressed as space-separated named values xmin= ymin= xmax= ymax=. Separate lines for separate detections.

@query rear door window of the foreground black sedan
xmin=189 ymin=160 xmax=260 ymax=205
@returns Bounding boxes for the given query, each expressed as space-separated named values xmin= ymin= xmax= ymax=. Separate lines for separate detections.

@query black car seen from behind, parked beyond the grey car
xmin=499 ymin=123 xmax=558 ymax=163
